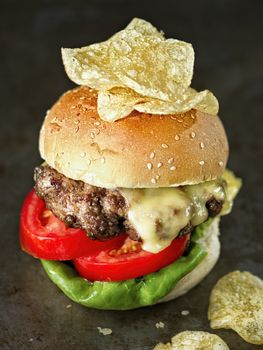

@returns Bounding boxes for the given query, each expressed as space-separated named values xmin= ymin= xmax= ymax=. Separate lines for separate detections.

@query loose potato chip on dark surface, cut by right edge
xmin=208 ymin=271 xmax=263 ymax=344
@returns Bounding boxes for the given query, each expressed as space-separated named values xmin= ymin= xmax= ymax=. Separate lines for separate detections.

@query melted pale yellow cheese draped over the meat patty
xmin=120 ymin=171 xmax=240 ymax=253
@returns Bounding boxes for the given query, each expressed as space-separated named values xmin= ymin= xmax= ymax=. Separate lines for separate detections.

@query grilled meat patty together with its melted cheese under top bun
xmin=35 ymin=165 xmax=226 ymax=253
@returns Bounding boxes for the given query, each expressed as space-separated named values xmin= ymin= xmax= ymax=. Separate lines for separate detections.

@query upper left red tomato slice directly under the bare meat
xmin=20 ymin=190 xmax=127 ymax=260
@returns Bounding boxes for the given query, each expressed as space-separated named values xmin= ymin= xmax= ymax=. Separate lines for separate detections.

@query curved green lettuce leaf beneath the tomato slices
xmin=41 ymin=243 xmax=206 ymax=310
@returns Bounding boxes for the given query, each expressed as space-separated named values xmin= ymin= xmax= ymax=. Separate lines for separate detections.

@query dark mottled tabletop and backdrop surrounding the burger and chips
xmin=0 ymin=0 xmax=263 ymax=350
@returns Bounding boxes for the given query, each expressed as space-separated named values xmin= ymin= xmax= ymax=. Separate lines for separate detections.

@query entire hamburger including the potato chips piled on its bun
xmin=20 ymin=19 xmax=240 ymax=310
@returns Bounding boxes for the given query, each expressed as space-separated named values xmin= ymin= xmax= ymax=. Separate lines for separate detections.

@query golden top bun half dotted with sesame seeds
xmin=39 ymin=87 xmax=228 ymax=188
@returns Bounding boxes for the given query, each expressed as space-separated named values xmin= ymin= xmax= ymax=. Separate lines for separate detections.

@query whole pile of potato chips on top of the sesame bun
xmin=62 ymin=18 xmax=218 ymax=121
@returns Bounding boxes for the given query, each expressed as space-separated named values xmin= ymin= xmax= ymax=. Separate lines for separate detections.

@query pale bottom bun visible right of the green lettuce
xmin=158 ymin=218 xmax=220 ymax=303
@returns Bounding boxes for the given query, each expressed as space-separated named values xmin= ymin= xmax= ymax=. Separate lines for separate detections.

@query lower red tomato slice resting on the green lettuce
xmin=73 ymin=235 xmax=189 ymax=281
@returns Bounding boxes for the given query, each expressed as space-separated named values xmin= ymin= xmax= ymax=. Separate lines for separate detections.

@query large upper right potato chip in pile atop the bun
xmin=109 ymin=30 xmax=194 ymax=101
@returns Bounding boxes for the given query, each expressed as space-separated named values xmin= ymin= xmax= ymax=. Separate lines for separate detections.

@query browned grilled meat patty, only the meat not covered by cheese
xmin=34 ymin=164 xmax=223 ymax=240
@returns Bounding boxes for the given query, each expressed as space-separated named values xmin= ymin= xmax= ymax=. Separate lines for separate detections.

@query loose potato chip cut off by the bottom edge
xmin=154 ymin=331 xmax=229 ymax=350
